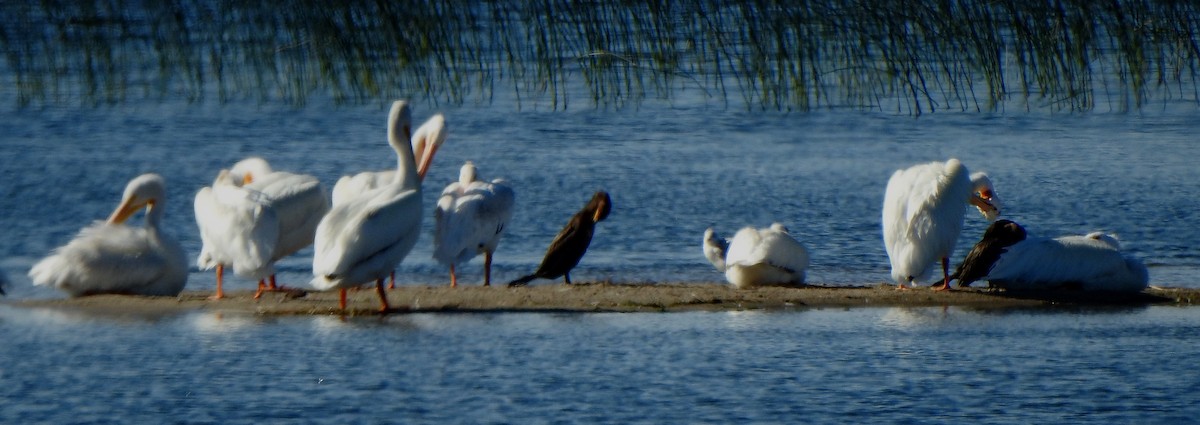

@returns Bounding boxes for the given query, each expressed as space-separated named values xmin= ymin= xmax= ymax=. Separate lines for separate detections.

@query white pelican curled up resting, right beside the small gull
xmin=720 ymin=223 xmax=809 ymax=288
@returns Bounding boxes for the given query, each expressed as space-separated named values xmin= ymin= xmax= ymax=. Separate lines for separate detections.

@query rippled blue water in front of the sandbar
xmin=0 ymin=303 xmax=1200 ymax=424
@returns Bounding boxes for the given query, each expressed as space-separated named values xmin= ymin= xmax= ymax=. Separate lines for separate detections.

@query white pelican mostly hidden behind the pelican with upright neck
xmin=334 ymin=110 xmax=448 ymax=204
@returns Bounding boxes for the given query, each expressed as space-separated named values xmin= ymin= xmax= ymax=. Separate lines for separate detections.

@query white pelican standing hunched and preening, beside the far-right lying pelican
xmin=883 ymin=158 xmax=1000 ymax=289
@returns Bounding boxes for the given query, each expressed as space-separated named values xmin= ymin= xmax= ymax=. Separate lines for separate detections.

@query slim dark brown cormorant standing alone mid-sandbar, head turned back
xmin=509 ymin=191 xmax=612 ymax=287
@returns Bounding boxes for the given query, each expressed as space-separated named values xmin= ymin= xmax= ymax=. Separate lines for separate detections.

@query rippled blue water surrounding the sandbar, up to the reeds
xmin=0 ymin=100 xmax=1200 ymax=424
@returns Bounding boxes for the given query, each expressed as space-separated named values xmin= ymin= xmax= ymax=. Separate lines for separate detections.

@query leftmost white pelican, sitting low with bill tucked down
xmin=29 ymin=174 xmax=187 ymax=297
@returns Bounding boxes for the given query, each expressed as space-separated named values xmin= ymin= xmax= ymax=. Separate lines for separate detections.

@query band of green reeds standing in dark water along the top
xmin=0 ymin=0 xmax=1200 ymax=114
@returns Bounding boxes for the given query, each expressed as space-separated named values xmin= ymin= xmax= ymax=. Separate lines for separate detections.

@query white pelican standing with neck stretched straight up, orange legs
xmin=312 ymin=101 xmax=422 ymax=311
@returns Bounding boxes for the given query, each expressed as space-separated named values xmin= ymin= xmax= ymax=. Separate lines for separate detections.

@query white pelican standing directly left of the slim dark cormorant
xmin=433 ymin=161 xmax=516 ymax=288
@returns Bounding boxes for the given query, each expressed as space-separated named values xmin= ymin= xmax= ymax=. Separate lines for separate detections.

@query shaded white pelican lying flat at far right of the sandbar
xmin=968 ymin=223 xmax=1150 ymax=292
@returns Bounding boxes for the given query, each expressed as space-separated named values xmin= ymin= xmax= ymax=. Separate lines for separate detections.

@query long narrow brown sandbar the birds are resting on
xmin=10 ymin=282 xmax=1200 ymax=316
